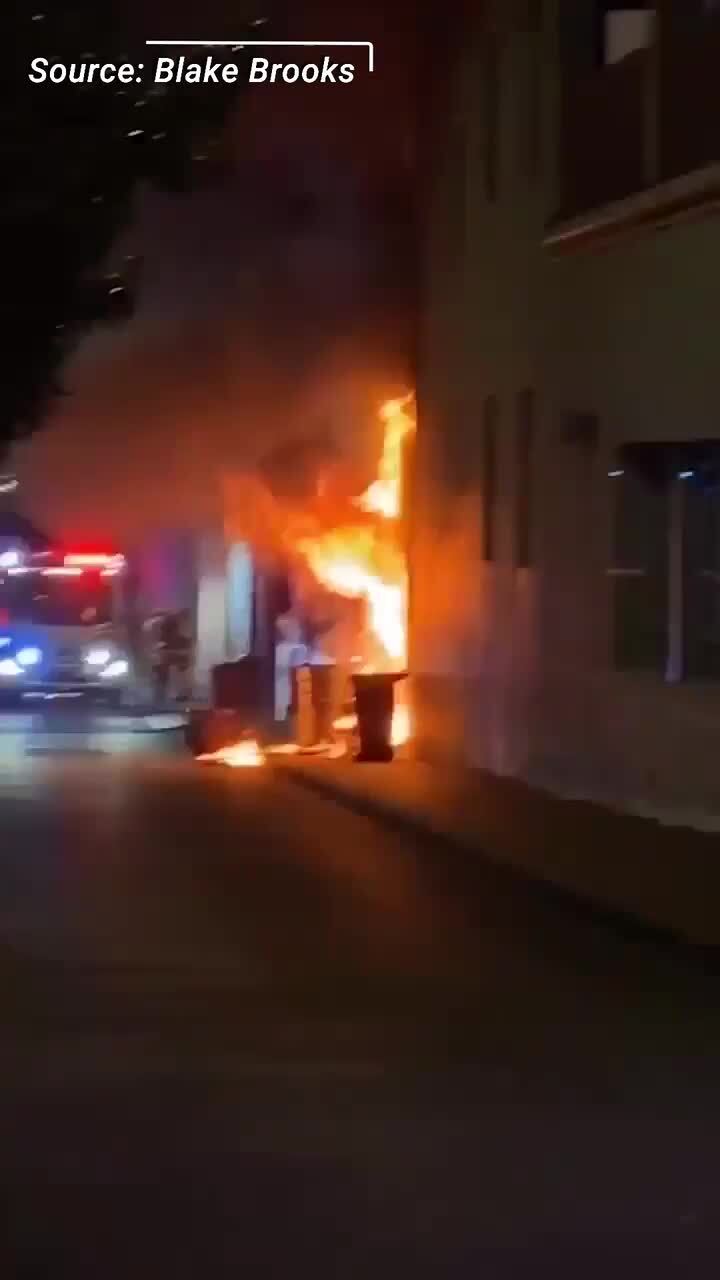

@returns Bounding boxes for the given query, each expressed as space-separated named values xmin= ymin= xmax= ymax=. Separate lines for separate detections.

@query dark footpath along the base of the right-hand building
xmin=282 ymin=756 xmax=720 ymax=947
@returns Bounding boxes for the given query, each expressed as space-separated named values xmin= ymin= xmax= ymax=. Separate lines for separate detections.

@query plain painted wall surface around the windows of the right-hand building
xmin=411 ymin=6 xmax=720 ymax=814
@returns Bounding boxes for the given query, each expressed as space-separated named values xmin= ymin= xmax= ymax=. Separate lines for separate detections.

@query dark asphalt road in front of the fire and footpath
xmin=0 ymin=727 xmax=720 ymax=1280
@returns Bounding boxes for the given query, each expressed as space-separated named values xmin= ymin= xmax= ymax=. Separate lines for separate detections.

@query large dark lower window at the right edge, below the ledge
xmin=610 ymin=442 xmax=720 ymax=682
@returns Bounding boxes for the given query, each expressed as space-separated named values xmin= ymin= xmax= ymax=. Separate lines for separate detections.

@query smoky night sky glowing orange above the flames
xmin=18 ymin=0 xmax=415 ymax=540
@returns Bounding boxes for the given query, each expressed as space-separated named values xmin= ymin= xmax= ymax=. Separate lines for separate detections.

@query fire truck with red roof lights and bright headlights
xmin=0 ymin=545 xmax=133 ymax=705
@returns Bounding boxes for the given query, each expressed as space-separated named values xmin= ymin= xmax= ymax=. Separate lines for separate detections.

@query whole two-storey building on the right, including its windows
xmin=411 ymin=0 xmax=720 ymax=814
